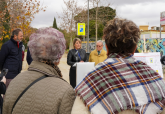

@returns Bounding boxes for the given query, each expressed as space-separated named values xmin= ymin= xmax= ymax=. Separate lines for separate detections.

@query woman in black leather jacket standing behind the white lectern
xmin=67 ymin=38 xmax=87 ymax=88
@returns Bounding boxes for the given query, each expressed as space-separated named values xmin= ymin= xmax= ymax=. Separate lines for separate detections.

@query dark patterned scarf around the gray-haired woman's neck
xmin=39 ymin=60 xmax=62 ymax=77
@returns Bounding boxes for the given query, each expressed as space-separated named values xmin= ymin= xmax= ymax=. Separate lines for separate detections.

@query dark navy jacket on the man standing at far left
xmin=0 ymin=37 xmax=22 ymax=79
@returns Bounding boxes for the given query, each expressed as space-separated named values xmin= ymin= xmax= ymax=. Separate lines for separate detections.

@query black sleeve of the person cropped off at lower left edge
xmin=0 ymin=82 xmax=6 ymax=114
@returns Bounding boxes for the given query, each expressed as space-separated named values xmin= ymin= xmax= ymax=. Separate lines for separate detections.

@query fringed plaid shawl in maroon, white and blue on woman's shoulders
xmin=75 ymin=53 xmax=165 ymax=114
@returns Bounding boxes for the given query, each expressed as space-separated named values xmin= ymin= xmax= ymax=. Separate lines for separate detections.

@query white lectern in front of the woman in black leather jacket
xmin=76 ymin=62 xmax=95 ymax=85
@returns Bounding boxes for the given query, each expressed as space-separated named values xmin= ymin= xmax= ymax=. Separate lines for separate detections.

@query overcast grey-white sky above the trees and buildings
xmin=31 ymin=0 xmax=165 ymax=29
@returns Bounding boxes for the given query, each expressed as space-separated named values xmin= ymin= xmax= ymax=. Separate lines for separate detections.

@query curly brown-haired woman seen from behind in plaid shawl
xmin=72 ymin=18 xmax=165 ymax=114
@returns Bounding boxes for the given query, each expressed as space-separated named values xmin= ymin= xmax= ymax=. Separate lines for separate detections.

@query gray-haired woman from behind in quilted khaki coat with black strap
xmin=3 ymin=28 xmax=75 ymax=114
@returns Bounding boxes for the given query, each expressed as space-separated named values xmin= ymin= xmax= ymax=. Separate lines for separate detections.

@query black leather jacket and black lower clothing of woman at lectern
xmin=67 ymin=49 xmax=87 ymax=88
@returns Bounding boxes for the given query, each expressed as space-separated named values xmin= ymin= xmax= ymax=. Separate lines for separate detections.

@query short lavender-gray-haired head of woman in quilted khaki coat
xmin=28 ymin=28 xmax=66 ymax=63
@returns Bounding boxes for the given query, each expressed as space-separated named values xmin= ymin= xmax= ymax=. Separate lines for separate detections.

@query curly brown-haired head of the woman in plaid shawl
xmin=104 ymin=18 xmax=140 ymax=55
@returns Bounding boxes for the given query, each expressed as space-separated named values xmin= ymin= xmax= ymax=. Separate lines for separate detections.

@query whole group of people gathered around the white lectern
xmin=0 ymin=18 xmax=165 ymax=114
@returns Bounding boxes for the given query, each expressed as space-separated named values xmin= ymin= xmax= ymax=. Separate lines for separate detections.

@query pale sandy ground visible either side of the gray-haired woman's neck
xmin=22 ymin=53 xmax=70 ymax=82
